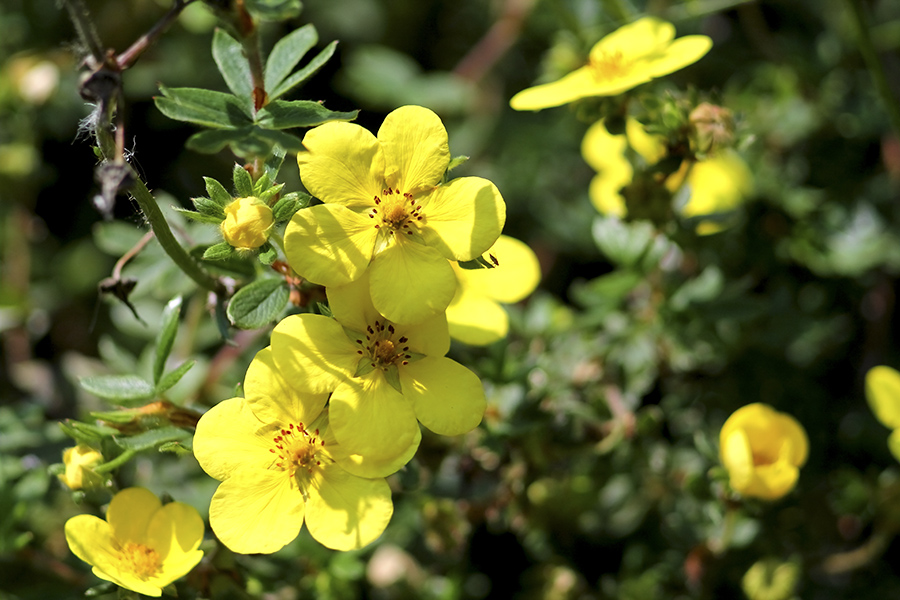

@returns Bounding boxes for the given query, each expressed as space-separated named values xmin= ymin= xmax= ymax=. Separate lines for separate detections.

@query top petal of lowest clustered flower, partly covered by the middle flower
xmin=244 ymin=347 xmax=328 ymax=432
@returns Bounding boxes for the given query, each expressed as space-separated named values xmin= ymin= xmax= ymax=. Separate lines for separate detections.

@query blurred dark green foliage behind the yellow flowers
xmin=0 ymin=0 xmax=900 ymax=599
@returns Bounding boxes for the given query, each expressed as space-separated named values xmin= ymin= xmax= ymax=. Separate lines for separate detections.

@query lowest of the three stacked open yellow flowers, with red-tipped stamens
xmin=194 ymin=348 xmax=394 ymax=554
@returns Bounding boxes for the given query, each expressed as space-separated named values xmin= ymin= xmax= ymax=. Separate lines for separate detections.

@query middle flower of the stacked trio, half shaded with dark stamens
xmin=272 ymin=276 xmax=486 ymax=474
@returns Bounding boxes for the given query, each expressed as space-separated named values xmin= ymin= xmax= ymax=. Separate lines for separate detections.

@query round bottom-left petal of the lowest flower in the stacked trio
xmin=209 ymin=469 xmax=304 ymax=554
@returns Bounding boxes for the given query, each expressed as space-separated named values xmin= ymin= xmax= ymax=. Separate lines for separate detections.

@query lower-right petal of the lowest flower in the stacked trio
xmin=306 ymin=465 xmax=394 ymax=550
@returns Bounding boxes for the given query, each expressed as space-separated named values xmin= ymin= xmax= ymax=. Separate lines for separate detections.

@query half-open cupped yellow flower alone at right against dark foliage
xmin=719 ymin=403 xmax=809 ymax=500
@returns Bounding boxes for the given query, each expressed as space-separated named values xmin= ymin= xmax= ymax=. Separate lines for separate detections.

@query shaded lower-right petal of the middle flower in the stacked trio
xmin=400 ymin=357 xmax=487 ymax=435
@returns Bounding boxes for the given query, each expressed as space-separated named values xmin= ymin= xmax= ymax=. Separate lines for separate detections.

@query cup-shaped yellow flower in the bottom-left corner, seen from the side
xmin=66 ymin=487 xmax=204 ymax=596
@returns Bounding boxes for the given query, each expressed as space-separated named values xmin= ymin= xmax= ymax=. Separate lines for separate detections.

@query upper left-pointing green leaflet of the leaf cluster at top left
xmin=153 ymin=86 xmax=253 ymax=129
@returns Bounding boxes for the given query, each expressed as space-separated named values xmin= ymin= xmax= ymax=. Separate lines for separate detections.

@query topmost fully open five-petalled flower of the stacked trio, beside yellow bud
xmin=285 ymin=106 xmax=506 ymax=323
